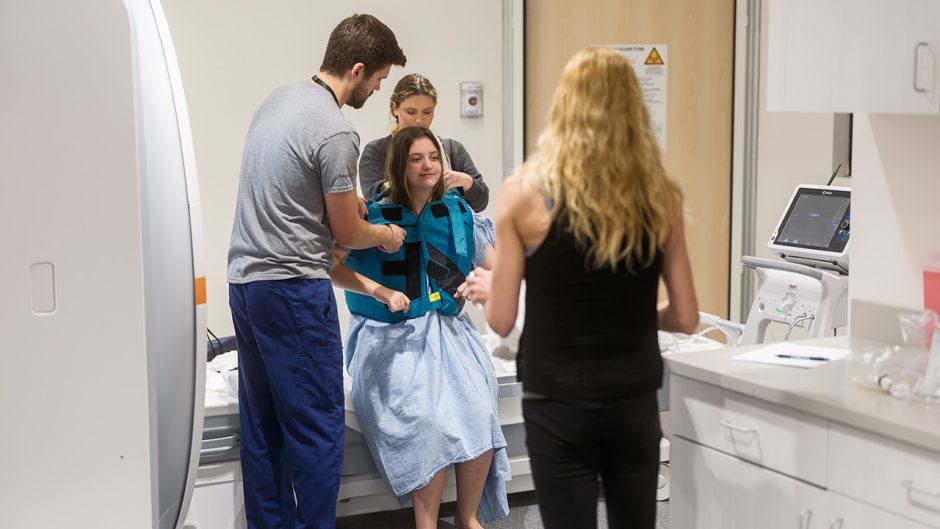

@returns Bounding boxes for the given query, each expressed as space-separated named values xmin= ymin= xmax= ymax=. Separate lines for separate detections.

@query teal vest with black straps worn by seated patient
xmin=345 ymin=190 xmax=474 ymax=323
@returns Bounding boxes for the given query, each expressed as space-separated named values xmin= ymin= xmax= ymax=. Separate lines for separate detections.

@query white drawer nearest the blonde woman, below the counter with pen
xmin=670 ymin=376 xmax=828 ymax=487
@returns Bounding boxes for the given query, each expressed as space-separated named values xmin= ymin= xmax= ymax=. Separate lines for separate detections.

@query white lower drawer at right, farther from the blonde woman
xmin=829 ymin=424 xmax=940 ymax=527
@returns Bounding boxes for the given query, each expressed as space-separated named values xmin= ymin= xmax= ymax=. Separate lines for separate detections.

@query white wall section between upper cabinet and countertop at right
xmin=849 ymin=114 xmax=940 ymax=308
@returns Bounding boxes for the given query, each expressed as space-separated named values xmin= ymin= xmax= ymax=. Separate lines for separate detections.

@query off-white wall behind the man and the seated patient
xmin=163 ymin=0 xmax=516 ymax=336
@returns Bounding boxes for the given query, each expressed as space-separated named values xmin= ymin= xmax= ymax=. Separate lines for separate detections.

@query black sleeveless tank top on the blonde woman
xmin=517 ymin=212 xmax=663 ymax=400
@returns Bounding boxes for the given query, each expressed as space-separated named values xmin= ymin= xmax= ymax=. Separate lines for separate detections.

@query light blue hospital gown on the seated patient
xmin=346 ymin=215 xmax=510 ymax=522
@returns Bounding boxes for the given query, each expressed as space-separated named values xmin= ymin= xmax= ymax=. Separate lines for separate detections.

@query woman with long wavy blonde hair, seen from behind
xmin=465 ymin=48 xmax=698 ymax=529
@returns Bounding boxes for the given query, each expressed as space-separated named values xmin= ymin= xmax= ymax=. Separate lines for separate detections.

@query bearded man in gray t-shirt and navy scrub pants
xmin=228 ymin=15 xmax=405 ymax=529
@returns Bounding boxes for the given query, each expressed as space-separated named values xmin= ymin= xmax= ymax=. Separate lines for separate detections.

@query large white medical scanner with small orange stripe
xmin=0 ymin=0 xmax=206 ymax=529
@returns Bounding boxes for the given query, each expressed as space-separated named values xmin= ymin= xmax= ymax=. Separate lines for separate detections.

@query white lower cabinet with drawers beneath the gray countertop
xmin=670 ymin=375 xmax=940 ymax=529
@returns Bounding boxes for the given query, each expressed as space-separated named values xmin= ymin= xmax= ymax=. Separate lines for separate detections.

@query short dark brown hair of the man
xmin=320 ymin=15 xmax=406 ymax=76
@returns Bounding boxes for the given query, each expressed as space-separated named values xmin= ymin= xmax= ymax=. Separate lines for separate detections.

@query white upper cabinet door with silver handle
xmin=767 ymin=0 xmax=940 ymax=114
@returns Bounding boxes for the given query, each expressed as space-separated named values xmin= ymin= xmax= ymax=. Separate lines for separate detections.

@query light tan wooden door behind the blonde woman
xmin=525 ymin=0 xmax=734 ymax=317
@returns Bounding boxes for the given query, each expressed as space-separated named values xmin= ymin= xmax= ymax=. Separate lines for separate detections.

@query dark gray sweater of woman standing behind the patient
xmin=359 ymin=134 xmax=490 ymax=212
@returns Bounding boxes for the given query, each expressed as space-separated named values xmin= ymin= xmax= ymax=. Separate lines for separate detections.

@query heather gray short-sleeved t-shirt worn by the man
xmin=228 ymin=81 xmax=359 ymax=283
